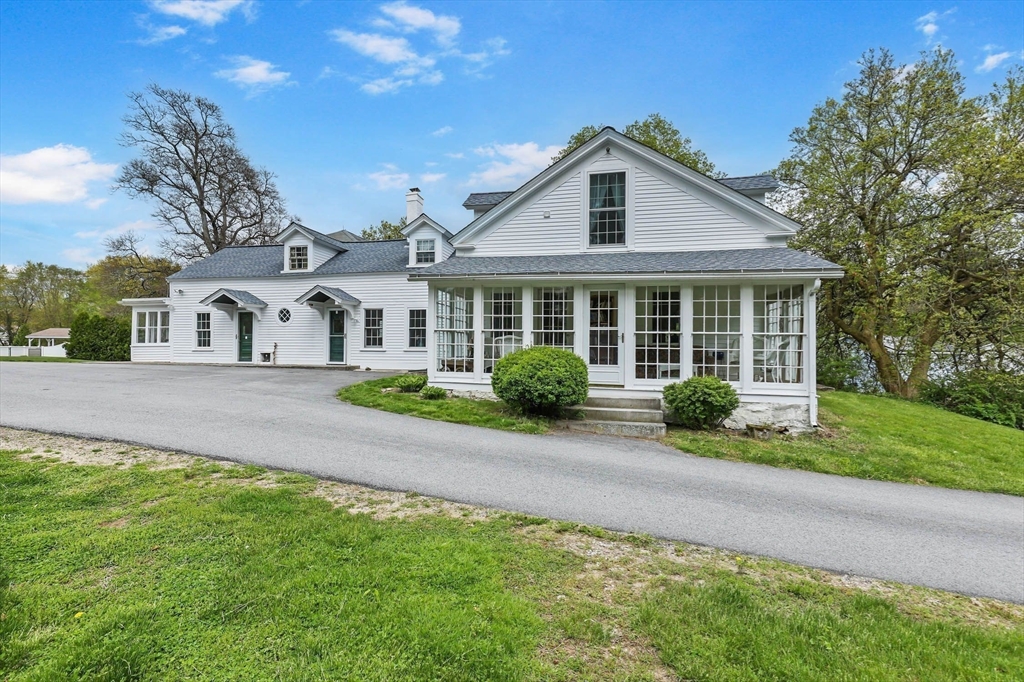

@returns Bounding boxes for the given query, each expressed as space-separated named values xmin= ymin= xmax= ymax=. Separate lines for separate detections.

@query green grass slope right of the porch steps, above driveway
xmin=667 ymin=391 xmax=1024 ymax=495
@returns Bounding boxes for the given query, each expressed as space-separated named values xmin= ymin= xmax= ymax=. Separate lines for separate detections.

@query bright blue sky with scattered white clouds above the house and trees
xmin=0 ymin=0 xmax=1024 ymax=267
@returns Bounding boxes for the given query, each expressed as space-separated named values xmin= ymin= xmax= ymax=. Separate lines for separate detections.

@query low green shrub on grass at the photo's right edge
xmin=920 ymin=370 xmax=1024 ymax=429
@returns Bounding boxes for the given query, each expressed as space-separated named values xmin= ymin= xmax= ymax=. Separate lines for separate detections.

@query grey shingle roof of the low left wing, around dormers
xmin=168 ymin=240 xmax=409 ymax=280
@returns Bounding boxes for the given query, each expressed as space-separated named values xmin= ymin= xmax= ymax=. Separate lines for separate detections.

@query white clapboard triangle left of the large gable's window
xmin=472 ymin=173 xmax=582 ymax=256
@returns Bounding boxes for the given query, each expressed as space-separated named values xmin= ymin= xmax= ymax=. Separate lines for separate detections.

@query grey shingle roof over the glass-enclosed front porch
xmin=410 ymin=248 xmax=843 ymax=280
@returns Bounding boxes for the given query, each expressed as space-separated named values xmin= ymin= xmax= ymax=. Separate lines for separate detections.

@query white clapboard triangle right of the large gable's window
xmin=634 ymin=168 xmax=771 ymax=251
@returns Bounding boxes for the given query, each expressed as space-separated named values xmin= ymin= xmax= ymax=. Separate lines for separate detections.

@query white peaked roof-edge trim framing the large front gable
xmin=452 ymin=126 xmax=800 ymax=247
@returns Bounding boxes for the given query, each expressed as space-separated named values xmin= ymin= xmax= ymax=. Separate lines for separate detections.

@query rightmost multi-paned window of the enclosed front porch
xmin=754 ymin=285 xmax=804 ymax=384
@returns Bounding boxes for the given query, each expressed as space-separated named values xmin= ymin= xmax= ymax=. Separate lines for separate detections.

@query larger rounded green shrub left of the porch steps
xmin=490 ymin=346 xmax=590 ymax=416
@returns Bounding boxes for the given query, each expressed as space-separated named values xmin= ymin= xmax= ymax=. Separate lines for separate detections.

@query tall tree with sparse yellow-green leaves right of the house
xmin=777 ymin=49 xmax=1024 ymax=397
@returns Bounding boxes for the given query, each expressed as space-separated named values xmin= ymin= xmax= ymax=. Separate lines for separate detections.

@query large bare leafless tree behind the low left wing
xmin=115 ymin=84 xmax=286 ymax=261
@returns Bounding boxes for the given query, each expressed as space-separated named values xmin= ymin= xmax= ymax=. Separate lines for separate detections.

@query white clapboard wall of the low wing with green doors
xmin=166 ymin=272 xmax=427 ymax=370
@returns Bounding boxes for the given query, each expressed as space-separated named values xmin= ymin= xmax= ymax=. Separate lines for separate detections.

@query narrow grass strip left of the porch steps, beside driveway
xmin=338 ymin=377 xmax=551 ymax=433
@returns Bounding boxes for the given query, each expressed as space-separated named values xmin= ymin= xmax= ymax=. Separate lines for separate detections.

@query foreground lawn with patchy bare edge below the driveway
xmin=0 ymin=429 xmax=1024 ymax=681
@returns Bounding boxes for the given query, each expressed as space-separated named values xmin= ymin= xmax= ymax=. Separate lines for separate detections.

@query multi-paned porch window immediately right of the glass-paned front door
xmin=636 ymin=287 xmax=682 ymax=379
